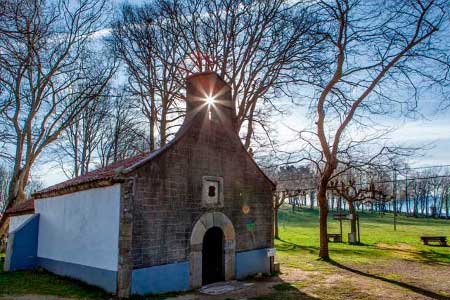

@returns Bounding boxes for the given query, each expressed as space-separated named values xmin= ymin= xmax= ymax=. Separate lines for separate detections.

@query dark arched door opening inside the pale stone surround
xmin=202 ymin=227 xmax=225 ymax=285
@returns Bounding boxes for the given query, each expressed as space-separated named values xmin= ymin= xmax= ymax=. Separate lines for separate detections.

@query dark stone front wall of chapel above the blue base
xmin=128 ymin=95 xmax=273 ymax=268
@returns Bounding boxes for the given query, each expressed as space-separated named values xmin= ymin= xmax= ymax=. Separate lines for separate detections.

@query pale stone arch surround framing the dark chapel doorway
xmin=189 ymin=212 xmax=236 ymax=289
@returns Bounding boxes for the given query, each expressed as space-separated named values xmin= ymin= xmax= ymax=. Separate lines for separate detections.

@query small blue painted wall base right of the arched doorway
xmin=236 ymin=249 xmax=270 ymax=279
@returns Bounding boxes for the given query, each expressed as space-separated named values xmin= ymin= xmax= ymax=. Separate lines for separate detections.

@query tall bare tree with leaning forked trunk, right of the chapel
xmin=296 ymin=0 xmax=449 ymax=258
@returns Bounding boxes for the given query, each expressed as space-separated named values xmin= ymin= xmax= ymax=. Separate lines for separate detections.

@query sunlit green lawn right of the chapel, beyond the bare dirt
xmin=275 ymin=209 xmax=450 ymax=269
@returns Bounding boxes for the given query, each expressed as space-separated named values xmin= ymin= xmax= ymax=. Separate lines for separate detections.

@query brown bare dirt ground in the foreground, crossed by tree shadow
xmin=0 ymin=260 xmax=450 ymax=300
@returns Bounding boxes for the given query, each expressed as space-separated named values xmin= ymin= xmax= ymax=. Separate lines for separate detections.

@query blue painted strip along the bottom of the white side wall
xmin=37 ymin=257 xmax=117 ymax=293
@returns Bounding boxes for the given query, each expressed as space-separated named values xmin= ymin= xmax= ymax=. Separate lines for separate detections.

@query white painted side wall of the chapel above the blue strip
xmin=35 ymin=184 xmax=120 ymax=271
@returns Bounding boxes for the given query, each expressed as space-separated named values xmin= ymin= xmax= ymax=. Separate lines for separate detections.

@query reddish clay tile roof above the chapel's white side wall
xmin=34 ymin=152 xmax=149 ymax=196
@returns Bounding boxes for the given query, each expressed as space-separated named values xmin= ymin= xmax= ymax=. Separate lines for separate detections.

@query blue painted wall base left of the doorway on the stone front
xmin=131 ymin=262 xmax=190 ymax=295
